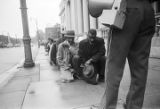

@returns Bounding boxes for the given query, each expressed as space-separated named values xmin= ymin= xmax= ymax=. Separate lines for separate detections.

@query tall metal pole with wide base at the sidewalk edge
xmin=20 ymin=0 xmax=35 ymax=67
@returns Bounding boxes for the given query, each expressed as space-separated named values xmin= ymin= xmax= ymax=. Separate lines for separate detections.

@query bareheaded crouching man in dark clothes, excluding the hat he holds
xmin=73 ymin=29 xmax=106 ymax=84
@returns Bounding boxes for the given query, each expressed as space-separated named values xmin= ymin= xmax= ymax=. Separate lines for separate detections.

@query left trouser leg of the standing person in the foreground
xmin=99 ymin=3 xmax=142 ymax=109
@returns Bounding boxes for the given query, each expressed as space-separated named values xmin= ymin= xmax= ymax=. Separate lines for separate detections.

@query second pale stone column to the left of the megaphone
xmin=76 ymin=0 xmax=83 ymax=34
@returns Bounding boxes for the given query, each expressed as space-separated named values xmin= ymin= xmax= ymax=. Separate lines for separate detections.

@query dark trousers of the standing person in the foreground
xmin=99 ymin=0 xmax=155 ymax=109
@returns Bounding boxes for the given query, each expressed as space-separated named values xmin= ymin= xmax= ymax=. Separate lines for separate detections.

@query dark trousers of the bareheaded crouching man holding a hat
xmin=72 ymin=55 xmax=106 ymax=77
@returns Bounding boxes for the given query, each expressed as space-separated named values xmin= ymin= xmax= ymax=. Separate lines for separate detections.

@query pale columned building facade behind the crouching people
xmin=59 ymin=0 xmax=160 ymax=38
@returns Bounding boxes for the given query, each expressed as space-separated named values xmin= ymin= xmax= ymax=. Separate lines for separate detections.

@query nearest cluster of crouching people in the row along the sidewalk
xmin=46 ymin=29 xmax=106 ymax=84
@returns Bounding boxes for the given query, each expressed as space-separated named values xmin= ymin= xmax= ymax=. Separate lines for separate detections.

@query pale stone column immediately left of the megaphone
xmin=82 ymin=0 xmax=90 ymax=32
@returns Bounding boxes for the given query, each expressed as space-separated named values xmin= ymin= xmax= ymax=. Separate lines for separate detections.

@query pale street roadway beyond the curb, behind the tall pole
xmin=0 ymin=45 xmax=38 ymax=88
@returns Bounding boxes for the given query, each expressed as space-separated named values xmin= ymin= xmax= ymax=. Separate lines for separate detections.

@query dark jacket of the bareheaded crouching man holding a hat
xmin=78 ymin=37 xmax=106 ymax=62
